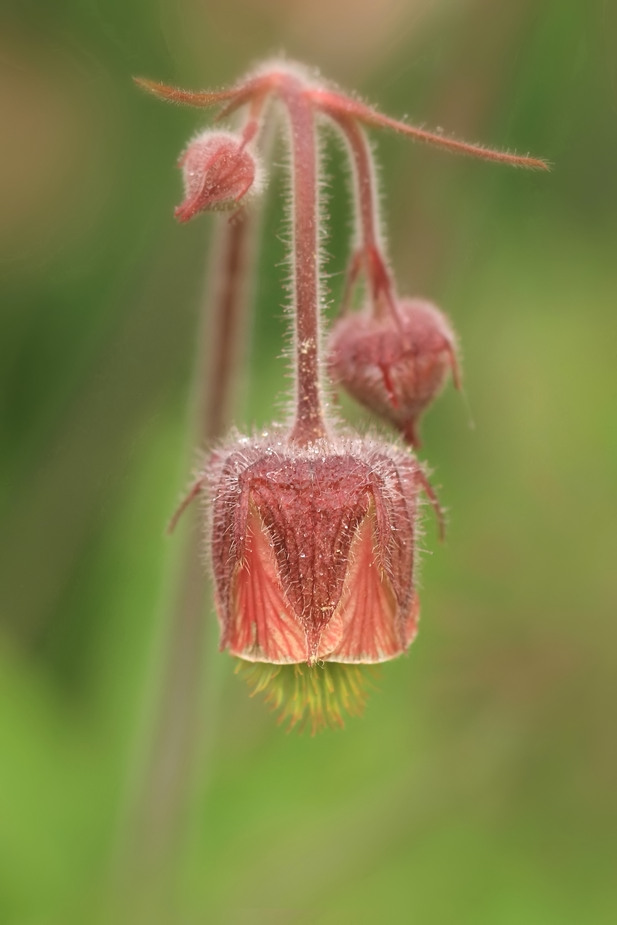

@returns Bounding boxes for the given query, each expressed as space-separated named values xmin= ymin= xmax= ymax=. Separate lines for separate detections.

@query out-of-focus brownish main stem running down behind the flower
xmin=121 ymin=210 xmax=258 ymax=905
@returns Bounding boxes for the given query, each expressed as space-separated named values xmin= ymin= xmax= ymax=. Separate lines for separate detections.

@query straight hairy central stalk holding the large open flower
xmin=280 ymin=75 xmax=327 ymax=446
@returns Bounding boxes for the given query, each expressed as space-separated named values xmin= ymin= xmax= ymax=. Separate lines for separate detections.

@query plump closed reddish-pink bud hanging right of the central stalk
xmin=328 ymin=298 xmax=459 ymax=446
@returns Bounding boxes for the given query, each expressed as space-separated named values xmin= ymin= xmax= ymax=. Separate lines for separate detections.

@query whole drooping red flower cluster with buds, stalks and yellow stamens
xmin=138 ymin=61 xmax=546 ymax=731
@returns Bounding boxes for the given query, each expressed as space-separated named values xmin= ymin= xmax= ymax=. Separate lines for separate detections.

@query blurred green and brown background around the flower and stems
xmin=0 ymin=0 xmax=617 ymax=925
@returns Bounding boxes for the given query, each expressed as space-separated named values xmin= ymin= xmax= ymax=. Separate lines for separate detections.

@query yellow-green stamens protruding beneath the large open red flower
xmin=235 ymin=659 xmax=378 ymax=735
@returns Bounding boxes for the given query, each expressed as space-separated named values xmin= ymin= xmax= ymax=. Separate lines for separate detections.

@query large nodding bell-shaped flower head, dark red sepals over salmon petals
xmin=204 ymin=438 xmax=420 ymax=666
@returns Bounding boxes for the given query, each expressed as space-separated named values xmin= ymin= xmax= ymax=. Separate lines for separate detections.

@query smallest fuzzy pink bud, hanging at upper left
xmin=174 ymin=131 xmax=261 ymax=222
